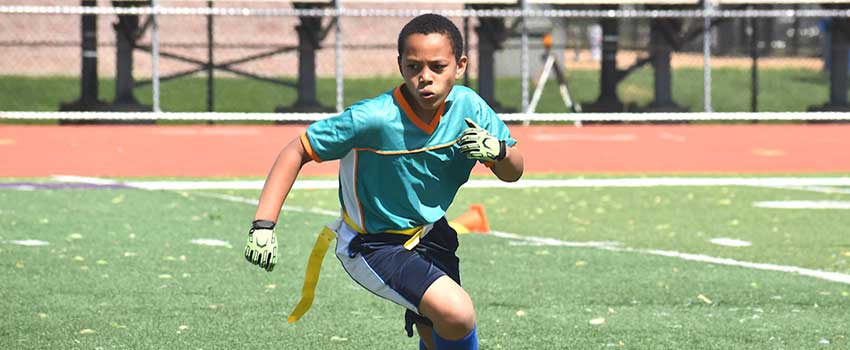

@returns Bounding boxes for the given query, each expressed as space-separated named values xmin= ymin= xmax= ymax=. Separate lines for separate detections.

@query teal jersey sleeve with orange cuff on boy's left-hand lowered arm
xmin=301 ymin=109 xmax=357 ymax=162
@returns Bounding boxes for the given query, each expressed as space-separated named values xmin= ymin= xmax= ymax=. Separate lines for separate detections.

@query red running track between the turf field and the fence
xmin=0 ymin=124 xmax=850 ymax=177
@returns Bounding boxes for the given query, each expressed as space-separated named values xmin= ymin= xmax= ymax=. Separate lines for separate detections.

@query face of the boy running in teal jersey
xmin=398 ymin=33 xmax=466 ymax=118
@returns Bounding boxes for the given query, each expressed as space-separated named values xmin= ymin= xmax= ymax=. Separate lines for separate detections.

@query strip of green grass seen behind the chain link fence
xmin=0 ymin=68 xmax=829 ymax=123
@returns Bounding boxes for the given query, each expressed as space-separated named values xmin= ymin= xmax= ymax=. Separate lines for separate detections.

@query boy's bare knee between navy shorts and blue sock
xmin=417 ymin=276 xmax=475 ymax=340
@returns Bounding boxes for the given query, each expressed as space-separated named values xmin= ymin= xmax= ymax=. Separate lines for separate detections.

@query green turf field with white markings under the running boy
xmin=0 ymin=178 xmax=850 ymax=349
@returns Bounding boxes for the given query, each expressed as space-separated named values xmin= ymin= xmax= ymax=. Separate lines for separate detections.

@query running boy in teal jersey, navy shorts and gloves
xmin=245 ymin=14 xmax=523 ymax=350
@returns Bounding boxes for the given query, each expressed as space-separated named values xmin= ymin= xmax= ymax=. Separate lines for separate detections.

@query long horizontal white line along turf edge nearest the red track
xmin=48 ymin=175 xmax=850 ymax=190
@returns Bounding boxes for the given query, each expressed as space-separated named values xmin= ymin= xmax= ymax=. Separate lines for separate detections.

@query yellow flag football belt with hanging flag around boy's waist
xmin=286 ymin=212 xmax=430 ymax=323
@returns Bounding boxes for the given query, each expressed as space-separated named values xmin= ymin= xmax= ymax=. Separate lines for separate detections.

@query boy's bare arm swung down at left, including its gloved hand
xmin=245 ymin=138 xmax=311 ymax=271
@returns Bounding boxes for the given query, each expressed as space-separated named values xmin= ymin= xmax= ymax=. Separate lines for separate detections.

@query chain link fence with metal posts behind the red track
xmin=0 ymin=0 xmax=846 ymax=117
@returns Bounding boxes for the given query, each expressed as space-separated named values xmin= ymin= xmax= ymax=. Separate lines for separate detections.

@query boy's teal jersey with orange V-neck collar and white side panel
xmin=301 ymin=86 xmax=516 ymax=233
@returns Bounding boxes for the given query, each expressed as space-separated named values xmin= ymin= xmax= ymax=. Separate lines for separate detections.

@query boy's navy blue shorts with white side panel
xmin=337 ymin=218 xmax=460 ymax=337
